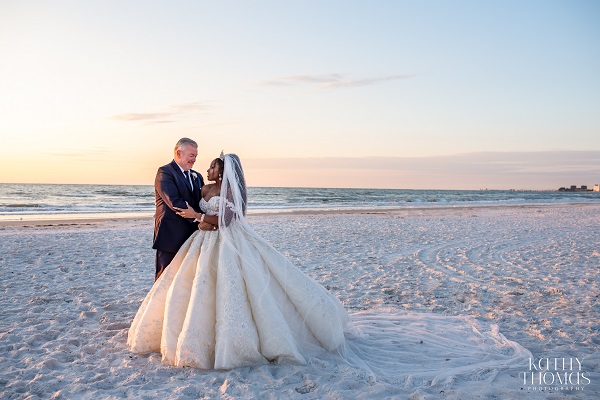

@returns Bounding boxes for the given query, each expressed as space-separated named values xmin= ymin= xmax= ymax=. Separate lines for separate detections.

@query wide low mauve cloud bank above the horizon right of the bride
xmin=242 ymin=151 xmax=600 ymax=190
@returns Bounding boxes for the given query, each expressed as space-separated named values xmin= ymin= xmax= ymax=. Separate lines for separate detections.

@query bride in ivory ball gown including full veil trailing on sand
xmin=127 ymin=154 xmax=531 ymax=388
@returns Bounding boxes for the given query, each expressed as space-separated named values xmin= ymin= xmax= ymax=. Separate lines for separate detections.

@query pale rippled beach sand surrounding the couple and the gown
xmin=0 ymin=205 xmax=600 ymax=399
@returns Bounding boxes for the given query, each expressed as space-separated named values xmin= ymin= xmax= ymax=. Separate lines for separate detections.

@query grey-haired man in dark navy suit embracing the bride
xmin=152 ymin=138 xmax=204 ymax=281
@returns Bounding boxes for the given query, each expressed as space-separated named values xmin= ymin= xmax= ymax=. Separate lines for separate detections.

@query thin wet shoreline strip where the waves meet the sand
xmin=0 ymin=202 xmax=600 ymax=228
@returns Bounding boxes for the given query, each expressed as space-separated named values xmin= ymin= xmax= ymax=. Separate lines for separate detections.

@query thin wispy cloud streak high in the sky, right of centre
xmin=260 ymin=74 xmax=415 ymax=89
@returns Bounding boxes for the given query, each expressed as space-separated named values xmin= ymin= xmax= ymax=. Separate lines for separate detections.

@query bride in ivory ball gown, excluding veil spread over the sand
xmin=127 ymin=154 xmax=348 ymax=369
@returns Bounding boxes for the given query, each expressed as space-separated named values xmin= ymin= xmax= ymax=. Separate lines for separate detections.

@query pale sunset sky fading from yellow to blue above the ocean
xmin=0 ymin=0 xmax=600 ymax=189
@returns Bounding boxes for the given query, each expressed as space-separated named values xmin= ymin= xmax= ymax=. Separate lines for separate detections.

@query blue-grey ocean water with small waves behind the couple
xmin=0 ymin=184 xmax=600 ymax=220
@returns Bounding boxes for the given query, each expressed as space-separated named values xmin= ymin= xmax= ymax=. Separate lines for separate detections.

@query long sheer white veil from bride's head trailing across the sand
xmin=219 ymin=154 xmax=531 ymax=387
